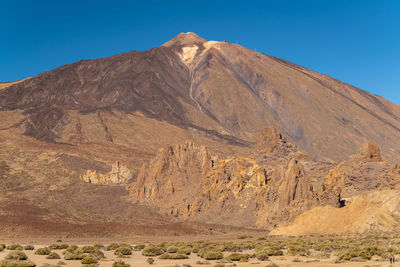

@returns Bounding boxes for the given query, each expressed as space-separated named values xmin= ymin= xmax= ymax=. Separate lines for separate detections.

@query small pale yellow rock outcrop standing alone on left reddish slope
xmin=80 ymin=161 xmax=132 ymax=184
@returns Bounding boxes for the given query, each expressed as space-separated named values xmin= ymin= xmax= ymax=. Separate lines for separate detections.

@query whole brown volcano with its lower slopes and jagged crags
xmin=0 ymin=33 xmax=400 ymax=235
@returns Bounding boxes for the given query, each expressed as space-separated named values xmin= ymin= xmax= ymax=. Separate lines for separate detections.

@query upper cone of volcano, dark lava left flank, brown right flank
xmin=0 ymin=33 xmax=400 ymax=162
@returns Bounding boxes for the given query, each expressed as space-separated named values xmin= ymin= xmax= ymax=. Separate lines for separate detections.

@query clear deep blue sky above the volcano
xmin=0 ymin=0 xmax=400 ymax=104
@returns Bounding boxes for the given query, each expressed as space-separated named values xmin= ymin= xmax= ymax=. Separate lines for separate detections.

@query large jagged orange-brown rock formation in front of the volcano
xmin=131 ymin=129 xmax=339 ymax=228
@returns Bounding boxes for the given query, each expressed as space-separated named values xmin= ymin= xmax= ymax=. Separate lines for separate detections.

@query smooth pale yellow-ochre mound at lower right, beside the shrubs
xmin=270 ymin=190 xmax=400 ymax=236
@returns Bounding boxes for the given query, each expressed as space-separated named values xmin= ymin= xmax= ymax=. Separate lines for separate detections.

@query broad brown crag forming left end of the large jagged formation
xmin=131 ymin=142 xmax=213 ymax=209
